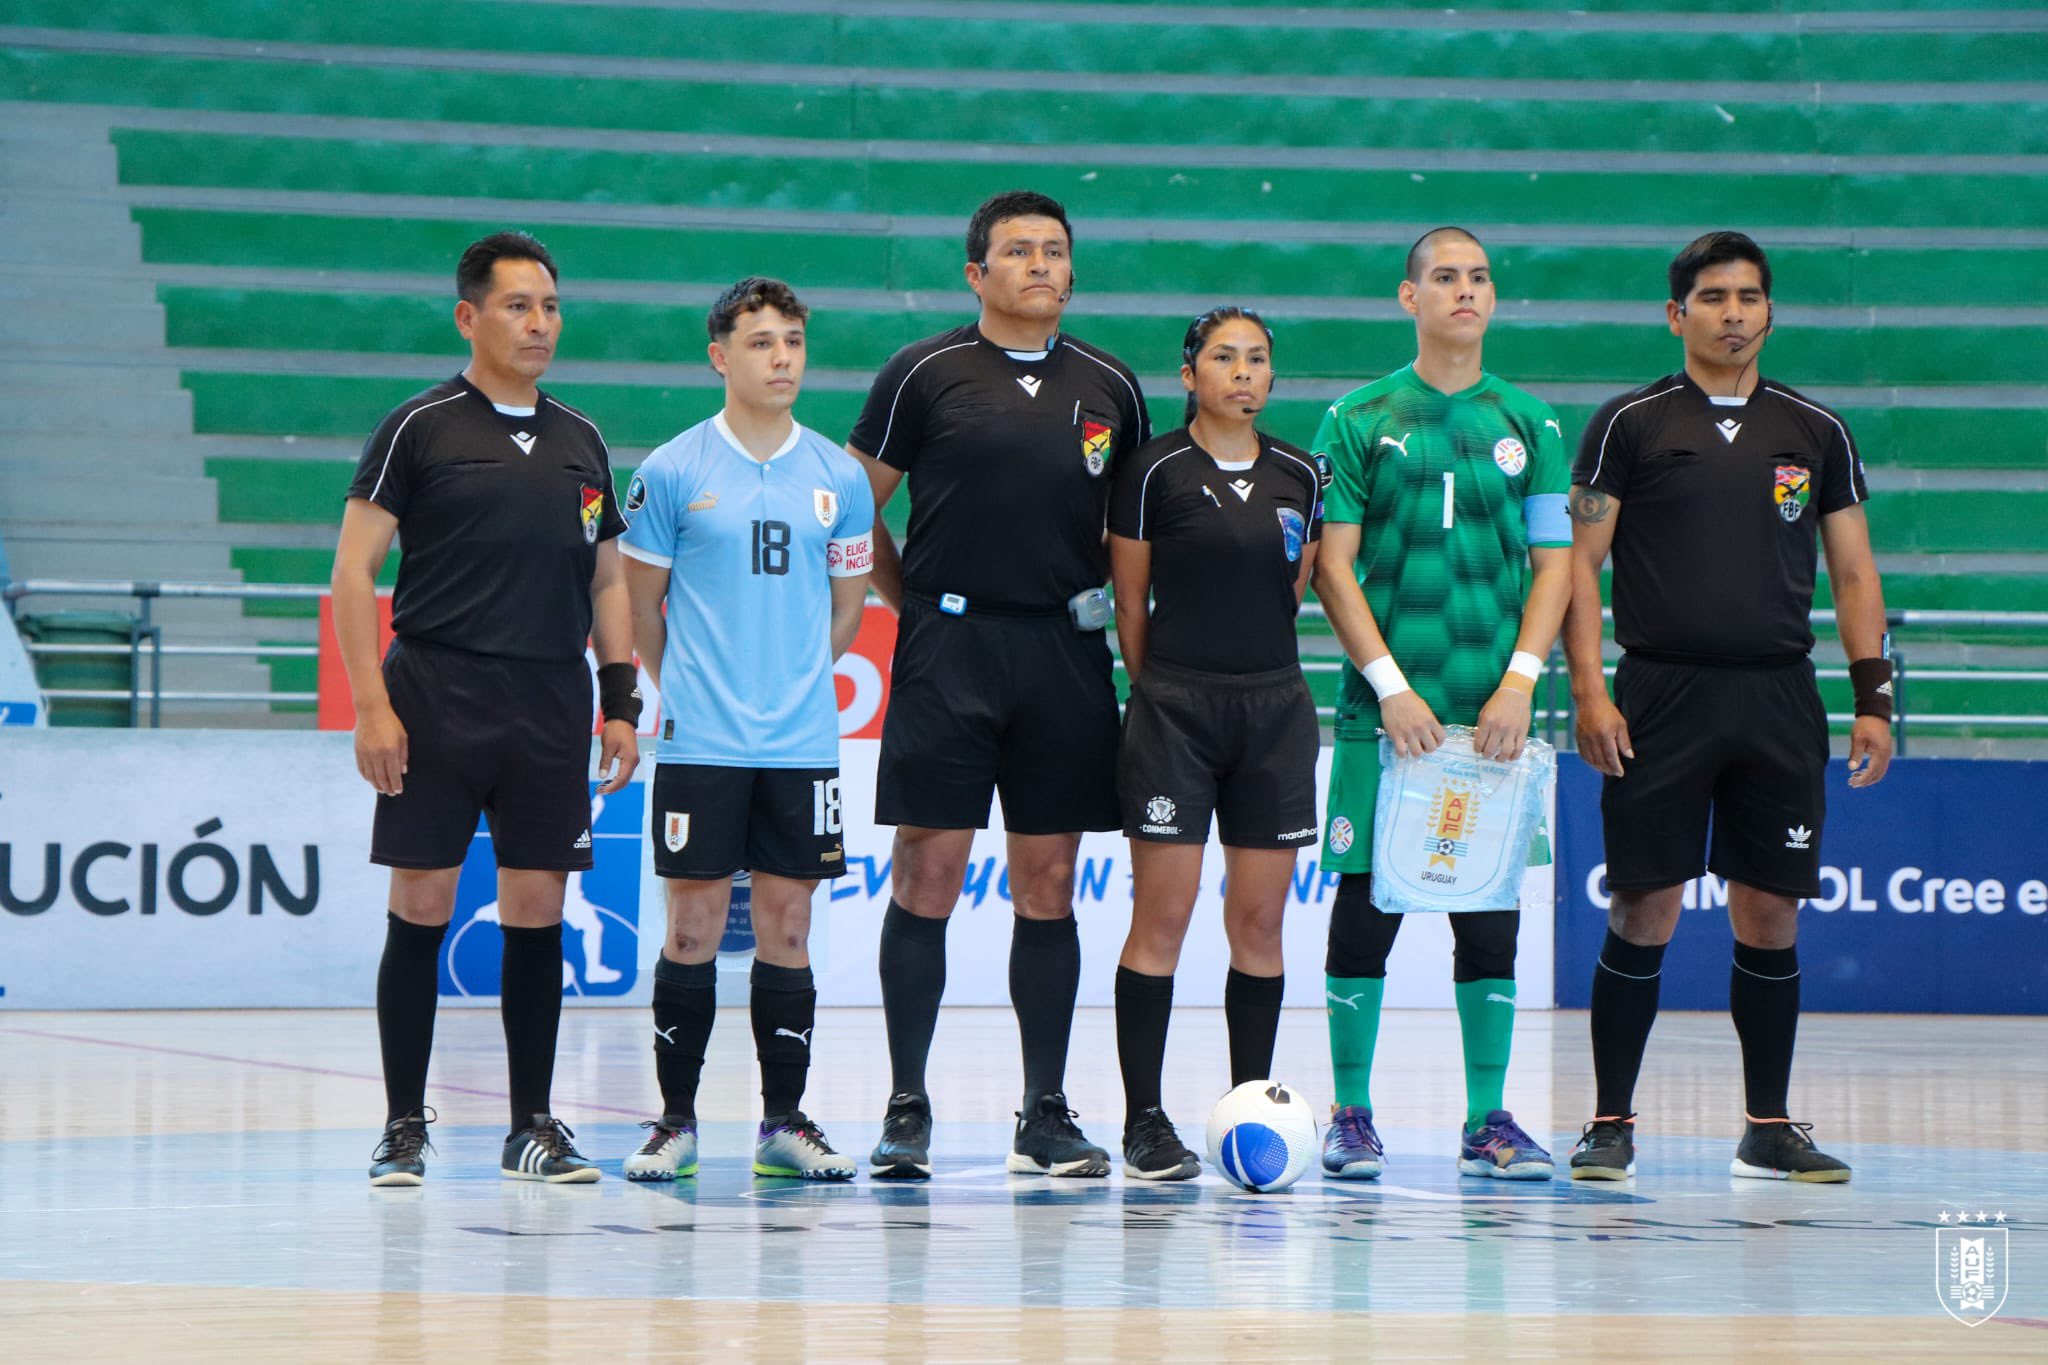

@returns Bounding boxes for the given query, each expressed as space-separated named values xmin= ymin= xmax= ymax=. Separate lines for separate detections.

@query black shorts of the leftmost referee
xmin=371 ymin=639 xmax=592 ymax=872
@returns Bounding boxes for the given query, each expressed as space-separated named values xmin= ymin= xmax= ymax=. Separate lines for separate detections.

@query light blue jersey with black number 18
xmin=618 ymin=411 xmax=874 ymax=767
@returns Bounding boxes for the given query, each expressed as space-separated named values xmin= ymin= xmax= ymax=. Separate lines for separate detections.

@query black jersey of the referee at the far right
xmin=1571 ymin=372 xmax=1868 ymax=665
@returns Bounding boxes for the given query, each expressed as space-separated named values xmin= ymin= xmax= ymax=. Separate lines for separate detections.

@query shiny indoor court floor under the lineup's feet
xmin=0 ymin=1009 xmax=2048 ymax=1363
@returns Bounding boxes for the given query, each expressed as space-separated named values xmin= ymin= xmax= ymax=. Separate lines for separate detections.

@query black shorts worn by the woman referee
xmin=1116 ymin=659 xmax=1321 ymax=849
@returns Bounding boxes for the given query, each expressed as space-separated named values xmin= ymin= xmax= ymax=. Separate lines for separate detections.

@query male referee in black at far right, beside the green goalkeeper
xmin=1565 ymin=231 xmax=1892 ymax=1181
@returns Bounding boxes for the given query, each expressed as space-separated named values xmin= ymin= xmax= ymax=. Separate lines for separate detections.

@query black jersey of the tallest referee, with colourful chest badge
xmin=846 ymin=323 xmax=1151 ymax=612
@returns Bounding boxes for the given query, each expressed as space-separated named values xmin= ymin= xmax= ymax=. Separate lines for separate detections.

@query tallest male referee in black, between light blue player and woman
xmin=846 ymin=190 xmax=1151 ymax=1179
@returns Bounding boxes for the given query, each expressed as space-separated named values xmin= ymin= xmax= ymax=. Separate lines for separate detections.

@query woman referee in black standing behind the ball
xmin=1110 ymin=307 xmax=1323 ymax=1181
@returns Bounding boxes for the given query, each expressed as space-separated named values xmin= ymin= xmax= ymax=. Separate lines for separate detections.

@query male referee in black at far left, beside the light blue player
xmin=334 ymin=233 xmax=639 ymax=1185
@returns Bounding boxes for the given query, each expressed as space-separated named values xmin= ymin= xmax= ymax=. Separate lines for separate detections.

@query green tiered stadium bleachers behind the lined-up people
xmin=0 ymin=0 xmax=2048 ymax=751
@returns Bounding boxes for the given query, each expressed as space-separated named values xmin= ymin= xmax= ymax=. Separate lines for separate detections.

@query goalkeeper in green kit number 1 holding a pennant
xmin=1313 ymin=227 xmax=1571 ymax=1181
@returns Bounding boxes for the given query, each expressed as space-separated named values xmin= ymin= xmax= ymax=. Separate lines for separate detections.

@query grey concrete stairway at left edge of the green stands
xmin=0 ymin=104 xmax=276 ymax=724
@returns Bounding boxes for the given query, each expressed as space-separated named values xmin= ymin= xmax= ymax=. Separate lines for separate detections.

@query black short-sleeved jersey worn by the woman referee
xmin=1110 ymin=428 xmax=1323 ymax=673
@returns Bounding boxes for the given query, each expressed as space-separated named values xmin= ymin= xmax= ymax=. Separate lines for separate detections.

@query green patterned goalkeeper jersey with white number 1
xmin=1315 ymin=366 xmax=1571 ymax=741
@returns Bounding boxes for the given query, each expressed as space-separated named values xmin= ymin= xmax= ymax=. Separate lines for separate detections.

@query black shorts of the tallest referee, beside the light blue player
xmin=874 ymin=600 xmax=1118 ymax=835
